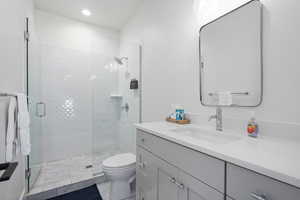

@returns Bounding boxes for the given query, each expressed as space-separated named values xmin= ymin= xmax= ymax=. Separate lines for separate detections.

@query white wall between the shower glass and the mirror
xmin=121 ymin=0 xmax=204 ymax=121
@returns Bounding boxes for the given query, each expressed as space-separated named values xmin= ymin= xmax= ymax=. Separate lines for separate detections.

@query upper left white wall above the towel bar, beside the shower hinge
xmin=0 ymin=0 xmax=25 ymax=91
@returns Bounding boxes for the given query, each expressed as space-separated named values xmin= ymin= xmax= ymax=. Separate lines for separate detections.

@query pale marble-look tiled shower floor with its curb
xmin=27 ymin=154 xmax=116 ymax=200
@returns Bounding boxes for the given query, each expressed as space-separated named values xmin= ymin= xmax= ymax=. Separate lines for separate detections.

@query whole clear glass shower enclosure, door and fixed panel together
xmin=30 ymin=41 xmax=132 ymax=187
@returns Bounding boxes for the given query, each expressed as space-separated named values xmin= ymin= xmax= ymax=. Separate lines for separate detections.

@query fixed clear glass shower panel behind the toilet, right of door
xmin=91 ymin=45 xmax=141 ymax=175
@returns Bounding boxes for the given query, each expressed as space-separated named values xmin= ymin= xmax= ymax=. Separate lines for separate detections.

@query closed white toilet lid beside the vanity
xmin=103 ymin=153 xmax=136 ymax=168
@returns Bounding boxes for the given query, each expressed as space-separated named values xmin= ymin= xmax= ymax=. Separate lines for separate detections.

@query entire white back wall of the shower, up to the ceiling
xmin=33 ymin=11 xmax=120 ymax=161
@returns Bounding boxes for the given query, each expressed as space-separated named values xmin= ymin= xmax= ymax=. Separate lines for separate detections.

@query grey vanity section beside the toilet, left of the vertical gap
xmin=137 ymin=131 xmax=224 ymax=200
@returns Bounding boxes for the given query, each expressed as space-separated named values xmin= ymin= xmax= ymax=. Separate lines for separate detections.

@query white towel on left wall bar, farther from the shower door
xmin=5 ymin=97 xmax=17 ymax=162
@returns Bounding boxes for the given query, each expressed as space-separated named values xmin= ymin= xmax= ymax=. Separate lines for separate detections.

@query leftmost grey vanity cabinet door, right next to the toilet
xmin=136 ymin=148 xmax=157 ymax=200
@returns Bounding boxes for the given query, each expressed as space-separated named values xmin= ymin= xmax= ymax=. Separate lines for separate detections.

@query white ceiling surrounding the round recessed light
xmin=35 ymin=0 xmax=142 ymax=29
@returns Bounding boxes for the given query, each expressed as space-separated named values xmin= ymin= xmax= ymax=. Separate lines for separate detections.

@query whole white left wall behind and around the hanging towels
xmin=0 ymin=0 xmax=33 ymax=200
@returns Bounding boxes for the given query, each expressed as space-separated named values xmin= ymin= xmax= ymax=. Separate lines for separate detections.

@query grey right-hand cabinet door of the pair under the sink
xmin=177 ymin=171 xmax=224 ymax=200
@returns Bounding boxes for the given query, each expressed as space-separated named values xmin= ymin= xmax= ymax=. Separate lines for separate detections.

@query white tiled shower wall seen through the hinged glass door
xmin=41 ymin=45 xmax=93 ymax=161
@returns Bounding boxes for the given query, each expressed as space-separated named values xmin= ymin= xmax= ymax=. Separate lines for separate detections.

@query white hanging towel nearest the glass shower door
xmin=17 ymin=93 xmax=31 ymax=156
